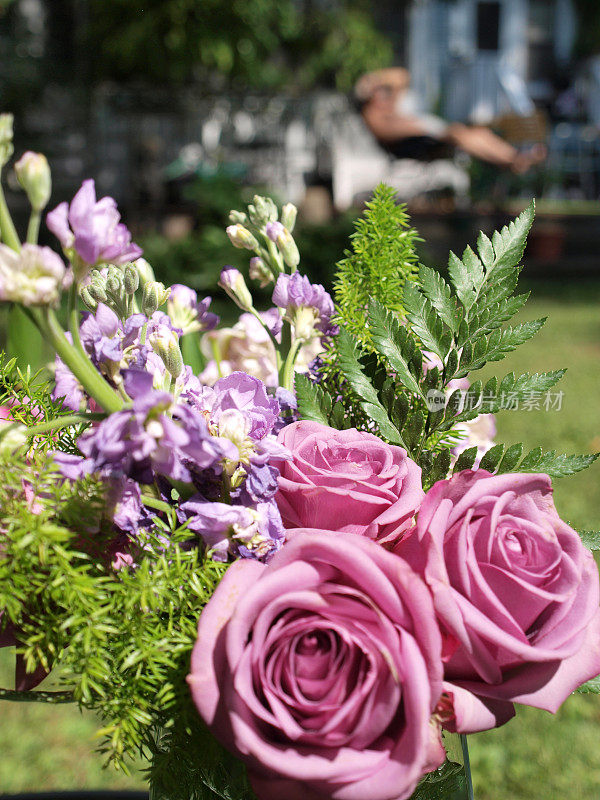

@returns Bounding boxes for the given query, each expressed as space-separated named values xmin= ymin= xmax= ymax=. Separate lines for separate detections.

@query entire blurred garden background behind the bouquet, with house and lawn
xmin=0 ymin=0 xmax=600 ymax=800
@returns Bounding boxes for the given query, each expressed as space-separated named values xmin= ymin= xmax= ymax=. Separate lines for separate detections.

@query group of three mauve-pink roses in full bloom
xmin=188 ymin=421 xmax=600 ymax=800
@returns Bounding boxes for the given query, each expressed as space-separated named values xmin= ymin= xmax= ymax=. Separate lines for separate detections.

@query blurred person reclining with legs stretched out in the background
xmin=354 ymin=67 xmax=546 ymax=173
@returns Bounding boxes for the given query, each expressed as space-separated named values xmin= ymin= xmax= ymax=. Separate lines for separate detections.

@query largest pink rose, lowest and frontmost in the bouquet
xmin=188 ymin=530 xmax=444 ymax=800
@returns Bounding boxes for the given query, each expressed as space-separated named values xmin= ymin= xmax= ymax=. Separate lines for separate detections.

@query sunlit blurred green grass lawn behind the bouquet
xmin=0 ymin=286 xmax=600 ymax=800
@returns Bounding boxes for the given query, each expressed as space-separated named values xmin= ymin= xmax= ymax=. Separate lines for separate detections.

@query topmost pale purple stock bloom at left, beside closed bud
xmin=46 ymin=180 xmax=142 ymax=266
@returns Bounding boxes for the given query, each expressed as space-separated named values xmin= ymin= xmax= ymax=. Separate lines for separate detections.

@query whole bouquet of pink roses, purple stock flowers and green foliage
xmin=0 ymin=115 xmax=600 ymax=800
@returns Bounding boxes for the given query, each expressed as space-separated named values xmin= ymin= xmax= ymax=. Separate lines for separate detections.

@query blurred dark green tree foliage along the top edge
xmin=88 ymin=0 xmax=392 ymax=90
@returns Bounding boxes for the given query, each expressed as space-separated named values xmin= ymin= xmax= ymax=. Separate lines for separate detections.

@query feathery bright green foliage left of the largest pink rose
xmin=0 ymin=452 xmax=226 ymax=769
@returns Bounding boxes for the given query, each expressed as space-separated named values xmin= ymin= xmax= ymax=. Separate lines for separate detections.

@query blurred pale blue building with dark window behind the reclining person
xmin=405 ymin=0 xmax=577 ymax=124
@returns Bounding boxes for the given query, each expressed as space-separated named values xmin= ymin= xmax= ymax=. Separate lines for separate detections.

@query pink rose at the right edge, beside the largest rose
xmin=395 ymin=470 xmax=600 ymax=733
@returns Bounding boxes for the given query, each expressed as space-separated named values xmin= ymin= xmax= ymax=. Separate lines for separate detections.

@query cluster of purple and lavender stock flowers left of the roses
xmin=40 ymin=188 xmax=333 ymax=565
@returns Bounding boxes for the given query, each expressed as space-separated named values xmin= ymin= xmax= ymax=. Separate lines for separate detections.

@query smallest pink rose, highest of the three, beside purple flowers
xmin=276 ymin=420 xmax=424 ymax=545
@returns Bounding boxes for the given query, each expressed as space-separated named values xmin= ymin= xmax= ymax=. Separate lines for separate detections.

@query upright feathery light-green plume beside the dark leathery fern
xmin=334 ymin=184 xmax=420 ymax=344
